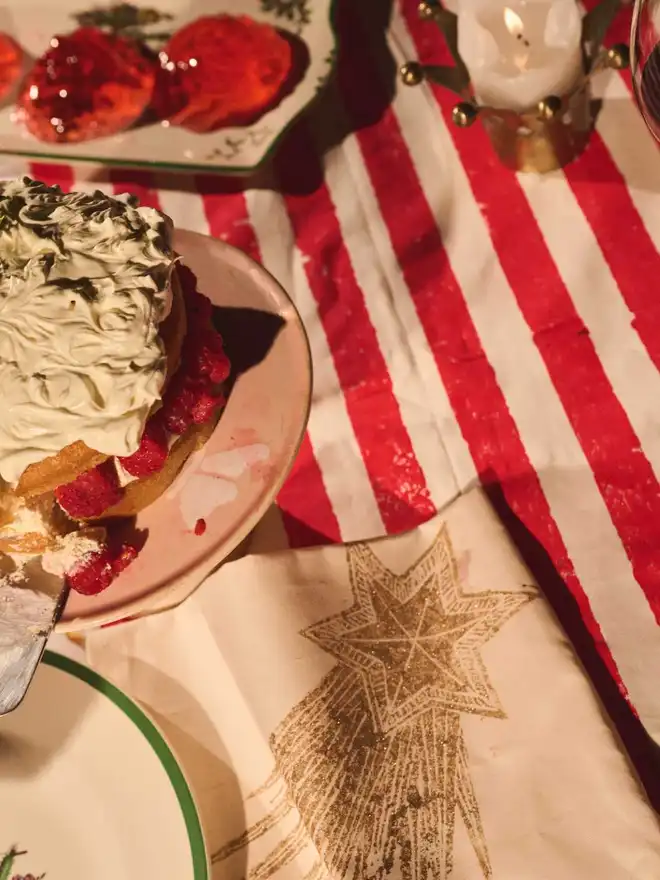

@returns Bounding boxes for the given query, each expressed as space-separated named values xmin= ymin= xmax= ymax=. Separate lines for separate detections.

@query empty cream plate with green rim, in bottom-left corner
xmin=0 ymin=652 xmax=209 ymax=880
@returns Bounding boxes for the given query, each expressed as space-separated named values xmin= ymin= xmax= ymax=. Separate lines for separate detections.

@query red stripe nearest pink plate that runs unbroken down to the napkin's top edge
xmin=277 ymin=126 xmax=435 ymax=533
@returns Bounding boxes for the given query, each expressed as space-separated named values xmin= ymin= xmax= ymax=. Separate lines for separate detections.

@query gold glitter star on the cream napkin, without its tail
xmin=305 ymin=533 xmax=534 ymax=732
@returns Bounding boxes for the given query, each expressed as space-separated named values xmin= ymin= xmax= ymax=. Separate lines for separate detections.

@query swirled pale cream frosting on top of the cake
xmin=0 ymin=178 xmax=174 ymax=484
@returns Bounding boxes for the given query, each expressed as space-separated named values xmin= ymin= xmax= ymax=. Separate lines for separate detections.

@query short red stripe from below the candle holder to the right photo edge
xmin=565 ymin=133 xmax=660 ymax=369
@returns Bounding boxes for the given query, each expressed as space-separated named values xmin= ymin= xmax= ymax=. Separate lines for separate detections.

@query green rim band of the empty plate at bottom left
xmin=42 ymin=651 xmax=210 ymax=880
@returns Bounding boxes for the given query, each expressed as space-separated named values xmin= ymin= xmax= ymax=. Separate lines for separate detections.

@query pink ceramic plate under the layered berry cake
xmin=58 ymin=232 xmax=311 ymax=632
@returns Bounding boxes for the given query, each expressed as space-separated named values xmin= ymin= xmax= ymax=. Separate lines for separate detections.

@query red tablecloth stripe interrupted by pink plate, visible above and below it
xmin=196 ymin=176 xmax=341 ymax=548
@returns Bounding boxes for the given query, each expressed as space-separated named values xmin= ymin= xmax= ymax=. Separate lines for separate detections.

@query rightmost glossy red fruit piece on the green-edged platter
xmin=156 ymin=15 xmax=292 ymax=133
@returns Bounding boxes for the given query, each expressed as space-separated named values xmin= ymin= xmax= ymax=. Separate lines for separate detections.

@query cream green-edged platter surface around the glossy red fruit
xmin=0 ymin=0 xmax=336 ymax=173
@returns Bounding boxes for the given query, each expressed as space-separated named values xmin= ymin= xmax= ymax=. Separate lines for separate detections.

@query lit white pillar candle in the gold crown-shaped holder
xmin=458 ymin=0 xmax=582 ymax=111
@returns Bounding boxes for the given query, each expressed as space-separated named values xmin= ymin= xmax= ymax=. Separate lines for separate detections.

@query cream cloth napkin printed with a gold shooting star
xmin=87 ymin=491 xmax=660 ymax=880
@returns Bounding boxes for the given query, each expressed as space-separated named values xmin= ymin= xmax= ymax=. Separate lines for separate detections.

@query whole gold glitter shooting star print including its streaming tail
xmin=213 ymin=526 xmax=536 ymax=880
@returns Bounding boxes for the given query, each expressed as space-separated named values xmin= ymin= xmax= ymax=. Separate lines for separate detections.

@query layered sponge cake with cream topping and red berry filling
xmin=0 ymin=178 xmax=229 ymax=594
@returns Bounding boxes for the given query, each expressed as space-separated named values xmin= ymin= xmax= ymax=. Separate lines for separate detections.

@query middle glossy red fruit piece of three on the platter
xmin=16 ymin=28 xmax=155 ymax=143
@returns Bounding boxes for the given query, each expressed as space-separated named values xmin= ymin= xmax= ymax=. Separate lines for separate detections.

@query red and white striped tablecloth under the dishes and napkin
xmin=2 ymin=0 xmax=660 ymax=752
